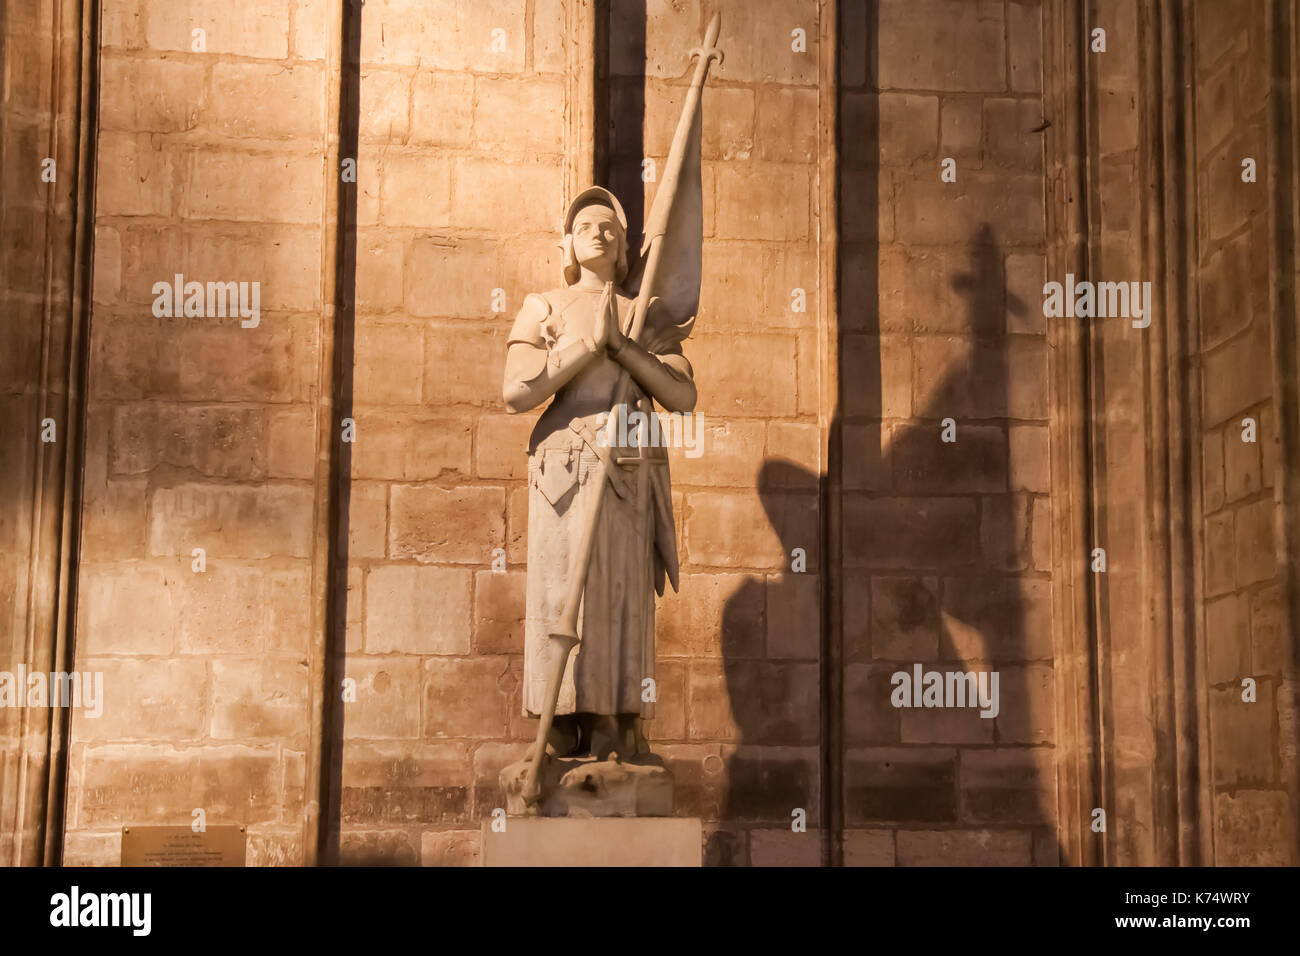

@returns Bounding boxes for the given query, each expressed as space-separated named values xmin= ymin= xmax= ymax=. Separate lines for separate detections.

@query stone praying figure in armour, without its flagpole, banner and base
xmin=502 ymin=186 xmax=696 ymax=760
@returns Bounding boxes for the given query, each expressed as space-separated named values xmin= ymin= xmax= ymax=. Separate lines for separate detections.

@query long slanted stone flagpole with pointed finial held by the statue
xmin=523 ymin=13 xmax=723 ymax=805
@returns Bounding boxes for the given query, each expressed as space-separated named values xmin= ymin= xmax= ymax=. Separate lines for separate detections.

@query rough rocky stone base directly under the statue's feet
xmin=501 ymin=753 xmax=672 ymax=817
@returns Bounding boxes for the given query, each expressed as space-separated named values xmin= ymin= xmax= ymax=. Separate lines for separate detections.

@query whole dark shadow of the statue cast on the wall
xmin=707 ymin=218 xmax=1060 ymax=865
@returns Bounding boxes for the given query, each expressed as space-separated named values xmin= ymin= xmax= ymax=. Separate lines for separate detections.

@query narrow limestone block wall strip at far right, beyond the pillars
xmin=1195 ymin=1 xmax=1295 ymax=865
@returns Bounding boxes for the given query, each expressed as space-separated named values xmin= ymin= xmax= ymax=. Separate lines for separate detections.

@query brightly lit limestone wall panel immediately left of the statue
xmin=342 ymin=0 xmax=564 ymax=864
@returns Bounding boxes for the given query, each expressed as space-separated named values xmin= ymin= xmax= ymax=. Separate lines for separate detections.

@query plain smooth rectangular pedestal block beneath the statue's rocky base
xmin=478 ymin=817 xmax=703 ymax=866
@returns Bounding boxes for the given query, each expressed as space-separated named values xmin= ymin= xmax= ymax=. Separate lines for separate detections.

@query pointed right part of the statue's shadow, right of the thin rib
xmin=845 ymin=222 xmax=1060 ymax=864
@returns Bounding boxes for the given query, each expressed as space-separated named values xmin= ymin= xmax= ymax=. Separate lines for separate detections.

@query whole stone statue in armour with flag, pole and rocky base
xmin=502 ymin=17 xmax=722 ymax=816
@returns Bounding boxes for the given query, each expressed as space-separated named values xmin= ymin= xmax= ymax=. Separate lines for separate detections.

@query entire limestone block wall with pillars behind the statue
xmin=12 ymin=0 xmax=1295 ymax=865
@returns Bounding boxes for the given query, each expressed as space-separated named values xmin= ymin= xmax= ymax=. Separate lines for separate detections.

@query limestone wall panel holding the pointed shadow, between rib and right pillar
xmin=840 ymin=0 xmax=1057 ymax=865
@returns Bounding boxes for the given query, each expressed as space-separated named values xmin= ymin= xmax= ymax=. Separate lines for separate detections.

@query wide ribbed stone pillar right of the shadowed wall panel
xmin=1047 ymin=0 xmax=1201 ymax=865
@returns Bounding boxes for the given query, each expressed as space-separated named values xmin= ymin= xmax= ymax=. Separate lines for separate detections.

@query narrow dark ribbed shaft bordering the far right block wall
xmin=1130 ymin=4 xmax=1214 ymax=865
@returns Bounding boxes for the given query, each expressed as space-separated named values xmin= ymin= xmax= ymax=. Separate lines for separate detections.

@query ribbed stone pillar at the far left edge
xmin=0 ymin=0 xmax=99 ymax=865
